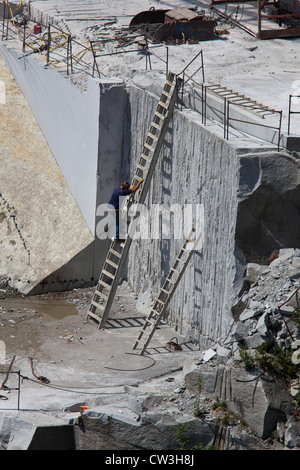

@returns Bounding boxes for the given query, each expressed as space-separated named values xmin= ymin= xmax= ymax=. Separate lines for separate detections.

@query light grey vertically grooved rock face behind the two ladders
xmin=128 ymin=82 xmax=239 ymax=344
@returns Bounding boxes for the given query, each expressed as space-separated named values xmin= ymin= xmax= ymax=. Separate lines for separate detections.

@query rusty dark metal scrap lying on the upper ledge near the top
xmin=129 ymin=7 xmax=217 ymax=44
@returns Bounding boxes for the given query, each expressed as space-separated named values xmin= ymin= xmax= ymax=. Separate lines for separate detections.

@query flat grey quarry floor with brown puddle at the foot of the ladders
xmin=0 ymin=283 xmax=200 ymax=414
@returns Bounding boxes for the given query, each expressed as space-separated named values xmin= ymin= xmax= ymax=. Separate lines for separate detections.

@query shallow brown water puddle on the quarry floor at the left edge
xmin=0 ymin=297 xmax=78 ymax=321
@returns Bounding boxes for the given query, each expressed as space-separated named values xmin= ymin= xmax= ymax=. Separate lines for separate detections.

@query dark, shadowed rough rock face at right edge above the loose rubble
xmin=236 ymin=152 xmax=300 ymax=264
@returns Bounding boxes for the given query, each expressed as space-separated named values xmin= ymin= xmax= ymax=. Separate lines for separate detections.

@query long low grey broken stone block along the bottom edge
xmin=74 ymin=412 xmax=218 ymax=451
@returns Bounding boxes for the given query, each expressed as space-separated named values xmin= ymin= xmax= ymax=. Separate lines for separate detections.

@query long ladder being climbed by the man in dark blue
xmin=87 ymin=73 xmax=181 ymax=328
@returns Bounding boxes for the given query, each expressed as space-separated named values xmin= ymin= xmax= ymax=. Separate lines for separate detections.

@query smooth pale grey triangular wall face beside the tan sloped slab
xmin=1 ymin=47 xmax=100 ymax=234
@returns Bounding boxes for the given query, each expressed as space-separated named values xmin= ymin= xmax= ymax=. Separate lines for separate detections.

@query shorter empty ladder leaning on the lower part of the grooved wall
xmin=132 ymin=230 xmax=199 ymax=355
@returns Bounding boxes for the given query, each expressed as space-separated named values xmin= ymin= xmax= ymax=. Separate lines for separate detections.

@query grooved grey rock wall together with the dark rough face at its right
xmin=125 ymin=80 xmax=300 ymax=346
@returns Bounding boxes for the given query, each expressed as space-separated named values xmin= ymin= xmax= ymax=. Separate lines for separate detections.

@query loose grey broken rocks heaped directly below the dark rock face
xmin=232 ymin=249 xmax=300 ymax=349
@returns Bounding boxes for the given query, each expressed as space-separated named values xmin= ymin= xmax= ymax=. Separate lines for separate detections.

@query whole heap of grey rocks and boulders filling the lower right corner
xmin=76 ymin=249 xmax=300 ymax=450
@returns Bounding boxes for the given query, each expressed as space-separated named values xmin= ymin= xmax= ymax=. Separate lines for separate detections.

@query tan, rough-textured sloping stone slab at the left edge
xmin=0 ymin=51 xmax=94 ymax=293
